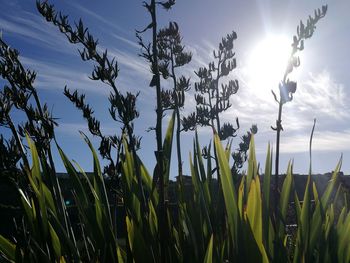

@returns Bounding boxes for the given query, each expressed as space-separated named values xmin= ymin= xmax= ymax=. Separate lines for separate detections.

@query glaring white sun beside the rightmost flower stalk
xmin=247 ymin=35 xmax=291 ymax=100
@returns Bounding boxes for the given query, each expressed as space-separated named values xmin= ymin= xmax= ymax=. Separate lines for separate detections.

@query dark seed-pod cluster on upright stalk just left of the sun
xmin=182 ymin=32 xmax=239 ymax=140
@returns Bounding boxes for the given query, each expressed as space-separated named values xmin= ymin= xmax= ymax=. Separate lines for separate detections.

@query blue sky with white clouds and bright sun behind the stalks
xmin=0 ymin=0 xmax=350 ymax=176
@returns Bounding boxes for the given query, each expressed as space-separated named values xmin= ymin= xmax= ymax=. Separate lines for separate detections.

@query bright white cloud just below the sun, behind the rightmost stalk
xmin=225 ymin=68 xmax=350 ymax=134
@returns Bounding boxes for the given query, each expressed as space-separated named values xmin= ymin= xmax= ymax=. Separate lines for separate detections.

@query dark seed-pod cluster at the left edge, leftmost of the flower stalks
xmin=0 ymin=36 xmax=57 ymax=159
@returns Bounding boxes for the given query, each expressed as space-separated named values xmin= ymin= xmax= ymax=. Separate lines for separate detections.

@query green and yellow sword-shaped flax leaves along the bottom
xmin=0 ymin=129 xmax=350 ymax=262
